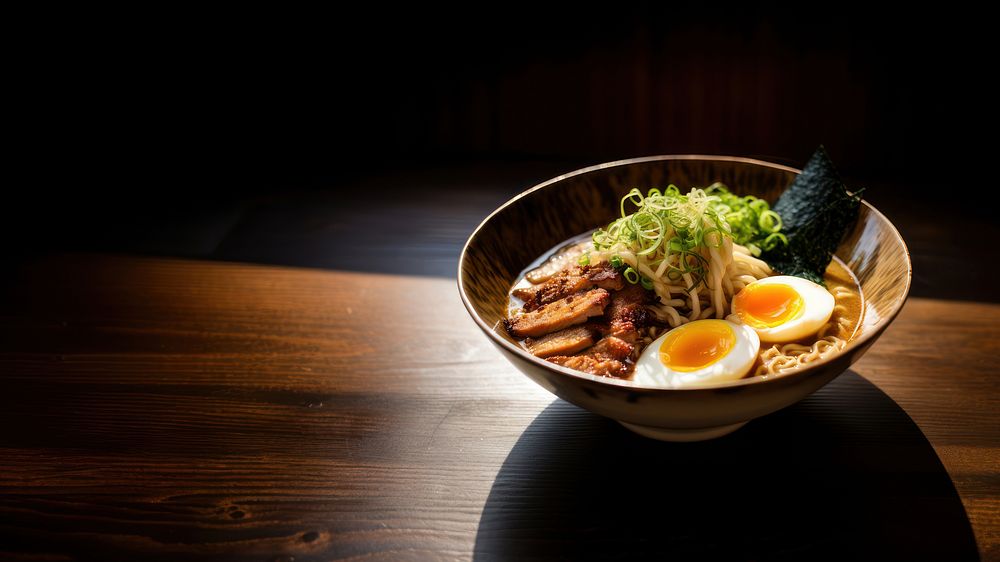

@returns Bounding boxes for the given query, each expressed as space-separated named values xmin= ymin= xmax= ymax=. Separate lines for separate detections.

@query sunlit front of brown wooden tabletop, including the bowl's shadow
xmin=0 ymin=255 xmax=1000 ymax=562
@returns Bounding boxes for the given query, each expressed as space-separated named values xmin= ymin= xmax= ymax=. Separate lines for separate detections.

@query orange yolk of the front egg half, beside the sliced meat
xmin=660 ymin=320 xmax=736 ymax=371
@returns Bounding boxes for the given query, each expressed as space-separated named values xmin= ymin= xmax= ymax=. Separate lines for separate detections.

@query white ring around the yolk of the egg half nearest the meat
xmin=632 ymin=320 xmax=760 ymax=388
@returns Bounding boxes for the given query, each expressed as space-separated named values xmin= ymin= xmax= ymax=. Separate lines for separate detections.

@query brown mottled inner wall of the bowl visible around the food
xmin=459 ymin=156 xmax=911 ymax=382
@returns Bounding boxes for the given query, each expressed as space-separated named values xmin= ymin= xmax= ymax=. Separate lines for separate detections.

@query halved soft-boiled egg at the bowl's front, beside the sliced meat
xmin=632 ymin=319 xmax=760 ymax=388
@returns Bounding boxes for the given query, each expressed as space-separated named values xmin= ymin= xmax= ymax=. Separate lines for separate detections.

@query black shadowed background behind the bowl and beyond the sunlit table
xmin=3 ymin=2 xmax=996 ymax=298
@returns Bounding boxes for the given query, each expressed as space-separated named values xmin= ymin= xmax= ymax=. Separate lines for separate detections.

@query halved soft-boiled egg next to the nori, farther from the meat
xmin=733 ymin=275 xmax=834 ymax=343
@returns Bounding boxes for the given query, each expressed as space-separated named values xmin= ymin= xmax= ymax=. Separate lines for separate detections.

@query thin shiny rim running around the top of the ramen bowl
xmin=458 ymin=154 xmax=913 ymax=392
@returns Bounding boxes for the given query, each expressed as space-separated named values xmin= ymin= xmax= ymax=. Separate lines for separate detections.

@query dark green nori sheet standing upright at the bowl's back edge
xmin=761 ymin=145 xmax=861 ymax=285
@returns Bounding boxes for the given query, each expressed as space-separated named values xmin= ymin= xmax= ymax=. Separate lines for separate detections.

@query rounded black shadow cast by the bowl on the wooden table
xmin=475 ymin=371 xmax=978 ymax=561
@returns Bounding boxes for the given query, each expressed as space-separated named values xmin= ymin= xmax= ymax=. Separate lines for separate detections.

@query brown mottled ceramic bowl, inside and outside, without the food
xmin=458 ymin=155 xmax=912 ymax=441
